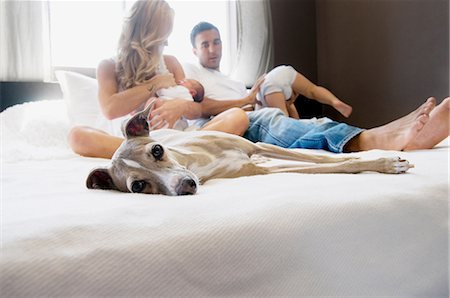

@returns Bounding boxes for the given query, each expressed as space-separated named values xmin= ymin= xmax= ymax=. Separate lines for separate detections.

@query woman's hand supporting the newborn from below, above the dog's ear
xmin=149 ymin=98 xmax=189 ymax=130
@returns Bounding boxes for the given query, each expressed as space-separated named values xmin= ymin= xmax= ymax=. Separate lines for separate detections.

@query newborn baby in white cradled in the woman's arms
xmin=156 ymin=79 xmax=205 ymax=130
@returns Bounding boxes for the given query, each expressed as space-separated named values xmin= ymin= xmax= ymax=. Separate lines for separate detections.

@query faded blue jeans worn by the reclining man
xmin=244 ymin=108 xmax=363 ymax=153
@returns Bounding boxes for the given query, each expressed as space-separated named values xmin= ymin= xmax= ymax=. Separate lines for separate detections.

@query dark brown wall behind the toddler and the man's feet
xmin=271 ymin=0 xmax=450 ymax=127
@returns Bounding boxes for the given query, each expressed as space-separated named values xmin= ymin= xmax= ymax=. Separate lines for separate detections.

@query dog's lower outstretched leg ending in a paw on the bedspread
xmin=264 ymin=157 xmax=414 ymax=174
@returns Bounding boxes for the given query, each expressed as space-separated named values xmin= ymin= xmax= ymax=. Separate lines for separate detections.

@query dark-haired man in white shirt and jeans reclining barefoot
xmin=184 ymin=22 xmax=450 ymax=153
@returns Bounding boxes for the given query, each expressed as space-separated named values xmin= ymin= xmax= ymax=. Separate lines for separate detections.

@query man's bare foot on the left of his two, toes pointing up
xmin=344 ymin=97 xmax=436 ymax=151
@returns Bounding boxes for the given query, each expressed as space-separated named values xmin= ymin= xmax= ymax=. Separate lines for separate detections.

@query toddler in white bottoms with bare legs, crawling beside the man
xmin=257 ymin=65 xmax=352 ymax=119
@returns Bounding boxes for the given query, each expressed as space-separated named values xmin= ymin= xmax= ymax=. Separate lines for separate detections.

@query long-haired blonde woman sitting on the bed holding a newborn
xmin=69 ymin=0 xmax=256 ymax=158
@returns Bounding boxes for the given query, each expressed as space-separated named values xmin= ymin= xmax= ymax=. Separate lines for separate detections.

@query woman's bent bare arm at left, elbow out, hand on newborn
xmin=97 ymin=60 xmax=175 ymax=120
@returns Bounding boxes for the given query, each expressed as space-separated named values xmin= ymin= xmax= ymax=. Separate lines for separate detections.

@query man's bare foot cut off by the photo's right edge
xmin=404 ymin=97 xmax=450 ymax=150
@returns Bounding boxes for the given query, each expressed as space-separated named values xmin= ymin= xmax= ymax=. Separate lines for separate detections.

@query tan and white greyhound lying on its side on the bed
xmin=86 ymin=104 xmax=413 ymax=196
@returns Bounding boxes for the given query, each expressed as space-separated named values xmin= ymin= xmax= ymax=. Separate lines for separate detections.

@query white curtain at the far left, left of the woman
xmin=0 ymin=0 xmax=51 ymax=81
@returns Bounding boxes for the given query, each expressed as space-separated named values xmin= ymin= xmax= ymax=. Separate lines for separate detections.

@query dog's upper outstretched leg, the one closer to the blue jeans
xmin=254 ymin=143 xmax=359 ymax=163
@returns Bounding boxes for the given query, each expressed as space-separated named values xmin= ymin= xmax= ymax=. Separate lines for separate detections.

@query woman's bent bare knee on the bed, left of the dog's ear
xmin=69 ymin=126 xmax=124 ymax=159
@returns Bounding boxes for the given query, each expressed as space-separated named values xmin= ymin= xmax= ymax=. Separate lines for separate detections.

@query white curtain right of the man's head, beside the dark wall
xmin=230 ymin=0 xmax=273 ymax=87
